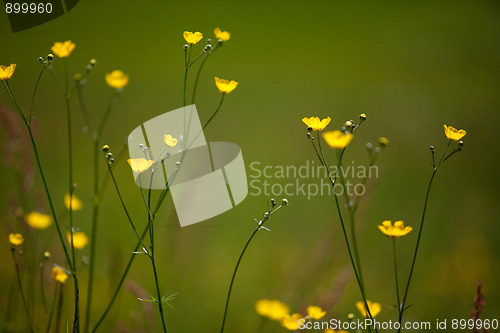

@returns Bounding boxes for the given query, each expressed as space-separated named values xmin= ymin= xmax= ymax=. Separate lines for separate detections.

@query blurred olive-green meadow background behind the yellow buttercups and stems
xmin=0 ymin=0 xmax=500 ymax=332
